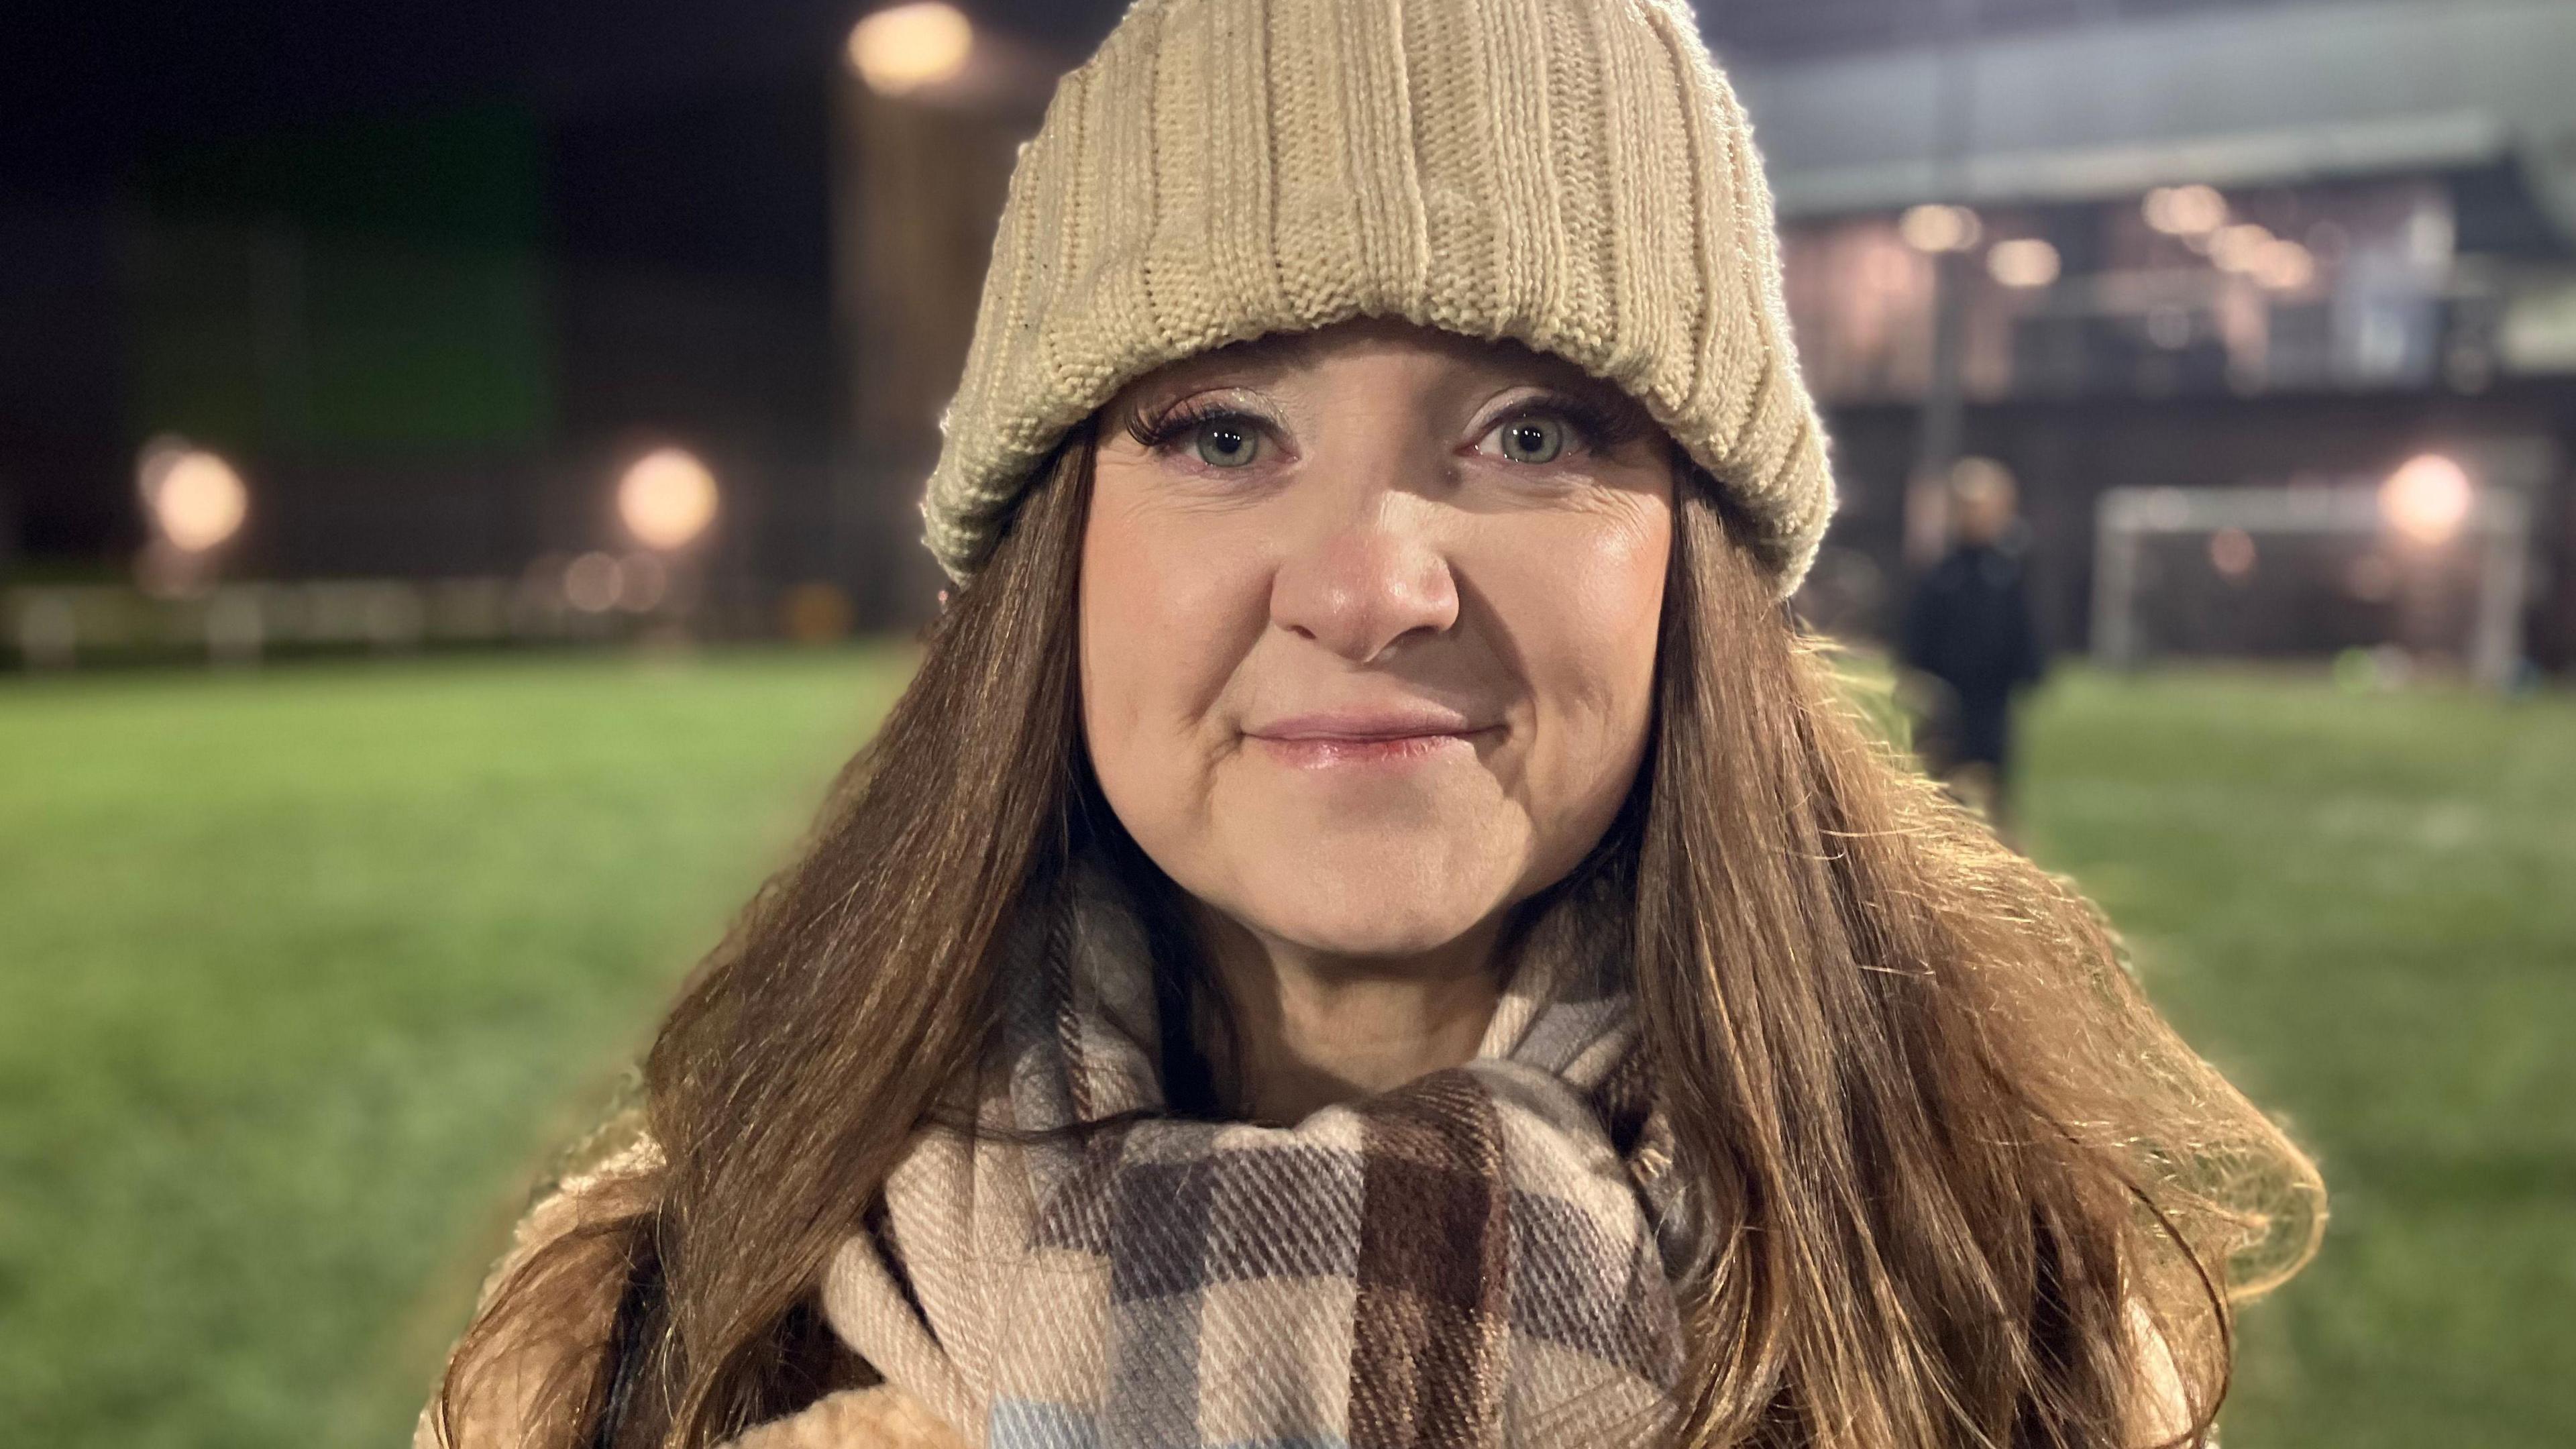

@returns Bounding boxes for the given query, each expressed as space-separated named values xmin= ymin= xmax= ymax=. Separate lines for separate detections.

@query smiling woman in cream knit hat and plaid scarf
xmin=423 ymin=0 xmax=2321 ymax=1449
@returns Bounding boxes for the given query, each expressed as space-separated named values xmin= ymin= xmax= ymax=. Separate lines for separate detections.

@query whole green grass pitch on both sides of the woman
xmin=0 ymin=652 xmax=2576 ymax=1449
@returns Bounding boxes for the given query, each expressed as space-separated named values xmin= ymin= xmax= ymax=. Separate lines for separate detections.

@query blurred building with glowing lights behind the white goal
xmin=1713 ymin=0 xmax=2576 ymax=667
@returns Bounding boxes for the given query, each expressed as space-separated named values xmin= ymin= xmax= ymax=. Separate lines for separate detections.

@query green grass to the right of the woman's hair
xmin=2027 ymin=673 xmax=2576 ymax=1449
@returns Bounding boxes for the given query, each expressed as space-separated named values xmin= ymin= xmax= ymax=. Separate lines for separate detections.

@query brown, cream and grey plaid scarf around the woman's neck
xmin=822 ymin=859 xmax=1705 ymax=1449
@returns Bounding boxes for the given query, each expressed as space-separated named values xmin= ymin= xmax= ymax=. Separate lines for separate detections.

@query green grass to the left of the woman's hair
xmin=0 ymin=655 xmax=922 ymax=1449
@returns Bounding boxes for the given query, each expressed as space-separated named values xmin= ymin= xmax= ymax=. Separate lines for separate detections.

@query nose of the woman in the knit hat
xmin=1270 ymin=495 xmax=1458 ymax=663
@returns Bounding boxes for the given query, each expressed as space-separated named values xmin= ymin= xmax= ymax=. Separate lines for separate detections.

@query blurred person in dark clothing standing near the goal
xmin=1898 ymin=459 xmax=2048 ymax=841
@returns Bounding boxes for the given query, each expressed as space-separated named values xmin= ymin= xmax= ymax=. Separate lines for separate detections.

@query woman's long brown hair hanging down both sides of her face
xmin=433 ymin=415 xmax=2324 ymax=1449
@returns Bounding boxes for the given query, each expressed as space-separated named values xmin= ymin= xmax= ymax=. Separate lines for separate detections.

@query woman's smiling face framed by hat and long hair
xmin=1082 ymin=320 xmax=1672 ymax=957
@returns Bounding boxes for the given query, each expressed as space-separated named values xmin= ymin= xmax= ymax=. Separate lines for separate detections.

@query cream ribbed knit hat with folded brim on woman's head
xmin=922 ymin=0 xmax=1834 ymax=596
